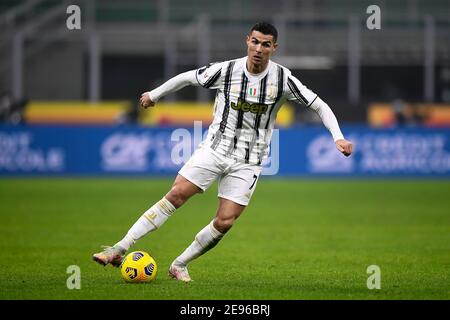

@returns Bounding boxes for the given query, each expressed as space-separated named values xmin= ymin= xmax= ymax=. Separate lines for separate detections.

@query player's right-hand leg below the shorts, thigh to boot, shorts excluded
xmin=169 ymin=198 xmax=245 ymax=282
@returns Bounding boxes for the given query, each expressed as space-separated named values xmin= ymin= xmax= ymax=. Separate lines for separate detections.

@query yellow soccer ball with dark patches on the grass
xmin=120 ymin=251 xmax=157 ymax=282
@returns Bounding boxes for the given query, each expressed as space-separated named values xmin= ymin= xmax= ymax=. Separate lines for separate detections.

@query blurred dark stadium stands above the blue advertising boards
xmin=0 ymin=0 xmax=450 ymax=126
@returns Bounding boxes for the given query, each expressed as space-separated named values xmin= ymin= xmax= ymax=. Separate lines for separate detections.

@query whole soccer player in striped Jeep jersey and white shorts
xmin=93 ymin=22 xmax=352 ymax=282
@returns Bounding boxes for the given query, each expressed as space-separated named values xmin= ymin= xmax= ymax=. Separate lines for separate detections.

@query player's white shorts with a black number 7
xmin=178 ymin=146 xmax=261 ymax=206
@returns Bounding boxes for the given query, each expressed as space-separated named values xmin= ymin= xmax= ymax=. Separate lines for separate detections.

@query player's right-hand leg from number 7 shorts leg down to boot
xmin=169 ymin=164 xmax=261 ymax=281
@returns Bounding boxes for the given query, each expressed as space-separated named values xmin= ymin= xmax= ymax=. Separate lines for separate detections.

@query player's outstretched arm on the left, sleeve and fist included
xmin=140 ymin=63 xmax=222 ymax=108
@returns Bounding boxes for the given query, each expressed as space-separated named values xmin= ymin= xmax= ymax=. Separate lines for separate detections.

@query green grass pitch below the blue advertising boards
xmin=0 ymin=178 xmax=450 ymax=300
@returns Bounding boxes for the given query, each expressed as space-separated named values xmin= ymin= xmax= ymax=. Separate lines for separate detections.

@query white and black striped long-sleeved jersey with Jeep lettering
xmin=149 ymin=57 xmax=343 ymax=164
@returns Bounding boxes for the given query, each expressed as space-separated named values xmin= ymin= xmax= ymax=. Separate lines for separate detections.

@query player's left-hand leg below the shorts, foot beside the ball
xmin=93 ymin=175 xmax=202 ymax=266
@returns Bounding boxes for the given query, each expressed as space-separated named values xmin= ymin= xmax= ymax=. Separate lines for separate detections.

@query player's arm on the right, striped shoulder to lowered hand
xmin=287 ymin=75 xmax=353 ymax=157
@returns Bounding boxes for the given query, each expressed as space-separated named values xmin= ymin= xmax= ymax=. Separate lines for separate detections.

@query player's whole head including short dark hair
xmin=247 ymin=22 xmax=278 ymax=66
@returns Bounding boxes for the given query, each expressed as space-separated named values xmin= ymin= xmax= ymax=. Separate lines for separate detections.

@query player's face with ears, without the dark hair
xmin=247 ymin=30 xmax=278 ymax=67
